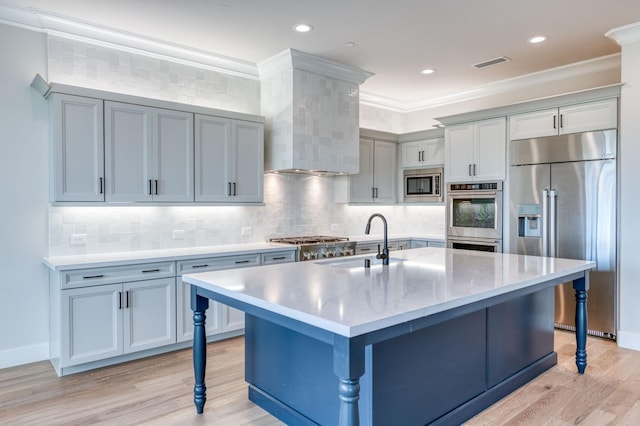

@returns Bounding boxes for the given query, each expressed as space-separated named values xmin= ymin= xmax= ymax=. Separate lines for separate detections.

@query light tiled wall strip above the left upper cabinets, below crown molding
xmin=48 ymin=36 xmax=260 ymax=115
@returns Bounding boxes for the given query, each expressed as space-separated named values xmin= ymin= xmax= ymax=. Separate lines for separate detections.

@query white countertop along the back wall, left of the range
xmin=43 ymin=243 xmax=297 ymax=271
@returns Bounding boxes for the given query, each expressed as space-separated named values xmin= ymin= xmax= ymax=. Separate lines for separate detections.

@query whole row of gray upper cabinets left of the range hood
xmin=41 ymin=81 xmax=264 ymax=204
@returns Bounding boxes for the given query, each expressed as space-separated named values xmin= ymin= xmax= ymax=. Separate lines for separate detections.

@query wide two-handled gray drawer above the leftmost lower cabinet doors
xmin=62 ymin=262 xmax=176 ymax=288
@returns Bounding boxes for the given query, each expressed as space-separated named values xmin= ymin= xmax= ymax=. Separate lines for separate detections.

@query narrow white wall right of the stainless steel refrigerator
xmin=618 ymin=37 xmax=640 ymax=350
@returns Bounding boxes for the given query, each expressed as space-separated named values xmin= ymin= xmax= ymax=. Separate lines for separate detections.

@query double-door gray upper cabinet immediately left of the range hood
xmin=195 ymin=114 xmax=264 ymax=203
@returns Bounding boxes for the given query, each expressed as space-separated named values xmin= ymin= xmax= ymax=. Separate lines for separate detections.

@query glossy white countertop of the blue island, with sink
xmin=183 ymin=247 xmax=595 ymax=337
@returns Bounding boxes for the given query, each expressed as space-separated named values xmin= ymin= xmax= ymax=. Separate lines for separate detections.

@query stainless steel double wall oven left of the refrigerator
xmin=447 ymin=182 xmax=502 ymax=252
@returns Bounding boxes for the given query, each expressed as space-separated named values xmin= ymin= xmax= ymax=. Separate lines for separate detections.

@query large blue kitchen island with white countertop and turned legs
xmin=183 ymin=248 xmax=595 ymax=425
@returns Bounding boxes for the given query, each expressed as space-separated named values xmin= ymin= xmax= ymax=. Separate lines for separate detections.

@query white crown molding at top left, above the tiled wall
xmin=0 ymin=5 xmax=259 ymax=80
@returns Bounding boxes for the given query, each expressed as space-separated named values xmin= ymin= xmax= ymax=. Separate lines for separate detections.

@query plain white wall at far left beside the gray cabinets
xmin=0 ymin=24 xmax=49 ymax=368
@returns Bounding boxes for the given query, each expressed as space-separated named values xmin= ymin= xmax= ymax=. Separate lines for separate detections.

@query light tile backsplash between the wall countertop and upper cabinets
xmin=49 ymin=174 xmax=444 ymax=256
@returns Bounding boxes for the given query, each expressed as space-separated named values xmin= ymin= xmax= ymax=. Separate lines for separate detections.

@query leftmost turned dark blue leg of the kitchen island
xmin=191 ymin=286 xmax=209 ymax=414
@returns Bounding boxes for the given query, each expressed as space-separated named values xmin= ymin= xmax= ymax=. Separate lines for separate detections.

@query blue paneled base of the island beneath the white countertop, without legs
xmin=245 ymin=288 xmax=557 ymax=425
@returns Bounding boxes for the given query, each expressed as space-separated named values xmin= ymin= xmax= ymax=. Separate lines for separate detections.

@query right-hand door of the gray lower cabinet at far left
xmin=123 ymin=278 xmax=176 ymax=353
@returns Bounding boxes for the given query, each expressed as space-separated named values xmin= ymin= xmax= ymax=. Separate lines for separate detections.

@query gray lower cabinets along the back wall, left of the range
xmin=49 ymin=248 xmax=296 ymax=376
